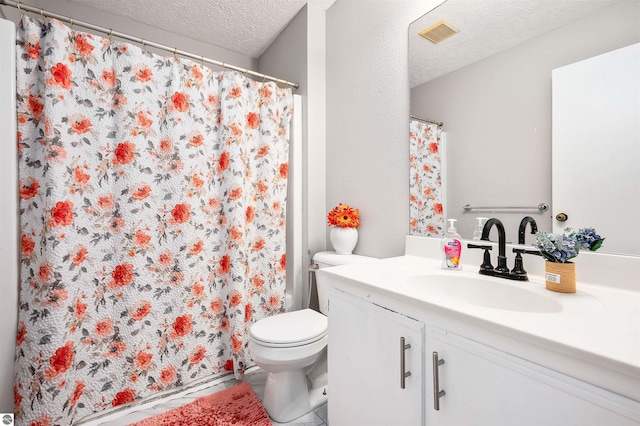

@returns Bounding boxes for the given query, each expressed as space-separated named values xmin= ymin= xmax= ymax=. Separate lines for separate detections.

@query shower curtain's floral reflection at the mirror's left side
xmin=409 ymin=120 xmax=444 ymax=237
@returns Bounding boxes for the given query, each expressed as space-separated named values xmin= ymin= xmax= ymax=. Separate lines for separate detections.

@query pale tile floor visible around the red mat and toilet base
xmin=81 ymin=367 xmax=328 ymax=426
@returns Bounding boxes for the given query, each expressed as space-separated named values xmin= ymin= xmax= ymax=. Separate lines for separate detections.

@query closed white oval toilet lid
xmin=251 ymin=309 xmax=327 ymax=346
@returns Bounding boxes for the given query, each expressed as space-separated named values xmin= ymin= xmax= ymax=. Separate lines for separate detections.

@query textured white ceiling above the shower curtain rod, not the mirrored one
xmin=69 ymin=0 xmax=335 ymax=58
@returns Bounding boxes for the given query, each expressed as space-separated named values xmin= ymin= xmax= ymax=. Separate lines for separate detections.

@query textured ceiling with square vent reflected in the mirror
xmin=409 ymin=0 xmax=620 ymax=87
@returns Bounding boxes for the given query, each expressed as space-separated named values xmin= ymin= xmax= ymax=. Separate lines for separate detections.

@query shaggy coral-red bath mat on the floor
xmin=130 ymin=383 xmax=273 ymax=426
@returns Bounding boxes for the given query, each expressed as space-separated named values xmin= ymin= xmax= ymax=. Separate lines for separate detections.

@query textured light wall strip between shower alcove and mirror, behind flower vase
xmin=325 ymin=0 xmax=441 ymax=257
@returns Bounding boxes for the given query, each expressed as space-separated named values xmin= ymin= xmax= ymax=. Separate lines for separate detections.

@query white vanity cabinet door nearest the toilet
xmin=328 ymin=289 xmax=424 ymax=426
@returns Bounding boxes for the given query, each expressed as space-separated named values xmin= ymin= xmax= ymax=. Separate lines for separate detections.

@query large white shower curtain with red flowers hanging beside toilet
xmin=14 ymin=17 xmax=292 ymax=425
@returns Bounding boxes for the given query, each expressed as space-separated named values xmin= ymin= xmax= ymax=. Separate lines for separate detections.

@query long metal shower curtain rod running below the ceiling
xmin=0 ymin=0 xmax=300 ymax=89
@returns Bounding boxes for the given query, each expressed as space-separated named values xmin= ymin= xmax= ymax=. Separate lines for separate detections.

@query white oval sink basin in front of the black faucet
xmin=407 ymin=272 xmax=562 ymax=313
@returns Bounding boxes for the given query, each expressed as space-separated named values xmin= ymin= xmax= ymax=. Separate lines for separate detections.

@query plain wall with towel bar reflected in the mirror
xmin=411 ymin=0 xmax=640 ymax=241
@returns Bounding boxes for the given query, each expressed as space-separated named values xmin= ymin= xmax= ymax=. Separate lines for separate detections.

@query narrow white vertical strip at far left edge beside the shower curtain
xmin=0 ymin=19 xmax=18 ymax=413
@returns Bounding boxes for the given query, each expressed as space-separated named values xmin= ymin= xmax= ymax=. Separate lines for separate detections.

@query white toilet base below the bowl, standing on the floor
xmin=262 ymin=369 xmax=327 ymax=423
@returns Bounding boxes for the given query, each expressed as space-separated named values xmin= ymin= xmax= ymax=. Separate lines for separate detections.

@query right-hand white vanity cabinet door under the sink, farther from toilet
xmin=426 ymin=328 xmax=640 ymax=426
